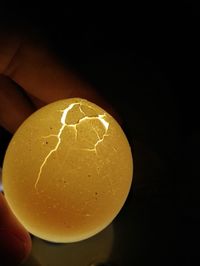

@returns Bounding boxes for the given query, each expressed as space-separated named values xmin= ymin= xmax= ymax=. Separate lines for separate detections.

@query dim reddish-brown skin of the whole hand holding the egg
xmin=0 ymin=34 xmax=115 ymax=264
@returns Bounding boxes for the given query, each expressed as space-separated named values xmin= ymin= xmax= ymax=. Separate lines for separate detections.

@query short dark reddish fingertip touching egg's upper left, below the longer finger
xmin=0 ymin=76 xmax=34 ymax=133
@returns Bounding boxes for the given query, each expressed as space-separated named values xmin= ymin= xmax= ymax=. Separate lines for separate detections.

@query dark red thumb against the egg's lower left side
xmin=0 ymin=193 xmax=31 ymax=265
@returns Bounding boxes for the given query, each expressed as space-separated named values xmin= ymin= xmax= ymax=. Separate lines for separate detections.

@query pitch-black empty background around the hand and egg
xmin=0 ymin=1 xmax=200 ymax=265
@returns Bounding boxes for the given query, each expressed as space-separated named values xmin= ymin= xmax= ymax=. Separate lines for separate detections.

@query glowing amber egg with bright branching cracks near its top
xmin=3 ymin=98 xmax=133 ymax=242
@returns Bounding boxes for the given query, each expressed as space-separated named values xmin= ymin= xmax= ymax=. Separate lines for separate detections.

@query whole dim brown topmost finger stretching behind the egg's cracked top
xmin=0 ymin=35 xmax=97 ymax=103
